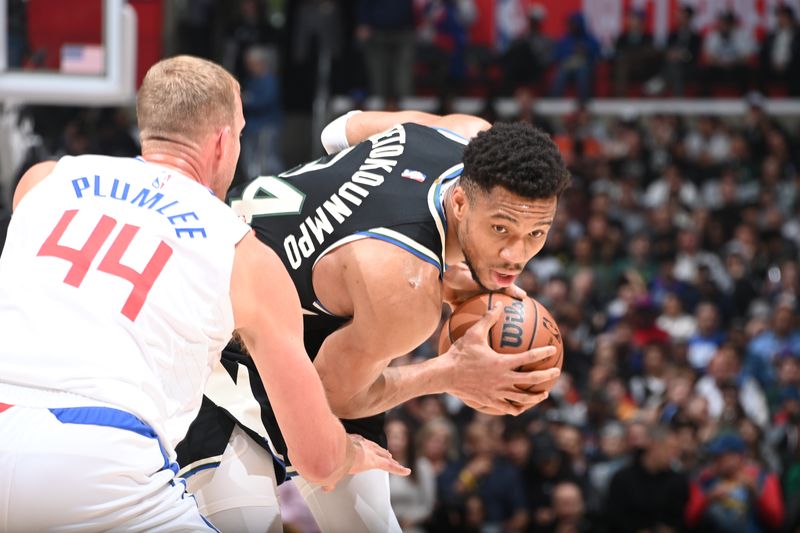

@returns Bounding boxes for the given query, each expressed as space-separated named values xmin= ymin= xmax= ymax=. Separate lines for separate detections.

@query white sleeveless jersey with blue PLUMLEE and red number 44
xmin=0 ymin=156 xmax=249 ymax=446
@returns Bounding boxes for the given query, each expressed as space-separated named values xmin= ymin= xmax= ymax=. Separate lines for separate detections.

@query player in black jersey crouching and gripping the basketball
xmin=178 ymin=112 xmax=569 ymax=532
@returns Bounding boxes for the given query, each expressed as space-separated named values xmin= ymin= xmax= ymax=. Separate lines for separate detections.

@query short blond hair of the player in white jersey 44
xmin=136 ymin=56 xmax=239 ymax=142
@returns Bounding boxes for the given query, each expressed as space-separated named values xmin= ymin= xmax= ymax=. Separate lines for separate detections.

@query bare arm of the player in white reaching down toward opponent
xmin=231 ymin=233 xmax=410 ymax=487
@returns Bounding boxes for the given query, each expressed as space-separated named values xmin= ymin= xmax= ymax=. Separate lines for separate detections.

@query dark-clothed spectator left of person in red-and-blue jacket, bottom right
xmin=605 ymin=426 xmax=688 ymax=533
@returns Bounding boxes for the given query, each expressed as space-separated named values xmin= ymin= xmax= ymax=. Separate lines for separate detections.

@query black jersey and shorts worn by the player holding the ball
xmin=178 ymin=124 xmax=467 ymax=478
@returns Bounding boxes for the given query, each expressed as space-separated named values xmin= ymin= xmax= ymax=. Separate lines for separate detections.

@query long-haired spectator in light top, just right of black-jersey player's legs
xmin=385 ymin=417 xmax=436 ymax=533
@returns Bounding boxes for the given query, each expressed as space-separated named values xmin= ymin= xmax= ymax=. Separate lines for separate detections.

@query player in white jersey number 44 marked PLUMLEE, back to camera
xmin=0 ymin=56 xmax=408 ymax=532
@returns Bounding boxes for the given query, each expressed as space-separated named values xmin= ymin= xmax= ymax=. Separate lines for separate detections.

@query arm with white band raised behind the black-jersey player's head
xmin=321 ymin=111 xmax=491 ymax=154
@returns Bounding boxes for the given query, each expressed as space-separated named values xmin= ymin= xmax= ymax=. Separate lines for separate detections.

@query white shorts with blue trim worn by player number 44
xmin=0 ymin=387 xmax=215 ymax=533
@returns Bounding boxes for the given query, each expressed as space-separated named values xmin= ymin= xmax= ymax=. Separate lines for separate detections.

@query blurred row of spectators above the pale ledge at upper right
xmin=355 ymin=0 xmax=800 ymax=107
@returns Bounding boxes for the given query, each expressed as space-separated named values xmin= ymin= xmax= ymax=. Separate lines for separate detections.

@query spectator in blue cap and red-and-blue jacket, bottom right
xmin=686 ymin=433 xmax=784 ymax=532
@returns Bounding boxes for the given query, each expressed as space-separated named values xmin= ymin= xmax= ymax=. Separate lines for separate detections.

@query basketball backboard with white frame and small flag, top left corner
xmin=0 ymin=0 xmax=136 ymax=106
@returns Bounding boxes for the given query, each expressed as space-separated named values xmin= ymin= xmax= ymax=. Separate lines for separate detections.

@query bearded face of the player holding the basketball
xmin=458 ymin=187 xmax=558 ymax=290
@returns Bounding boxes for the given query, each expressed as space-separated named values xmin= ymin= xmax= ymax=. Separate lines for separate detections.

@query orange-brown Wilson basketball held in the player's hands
xmin=439 ymin=292 xmax=564 ymax=391
